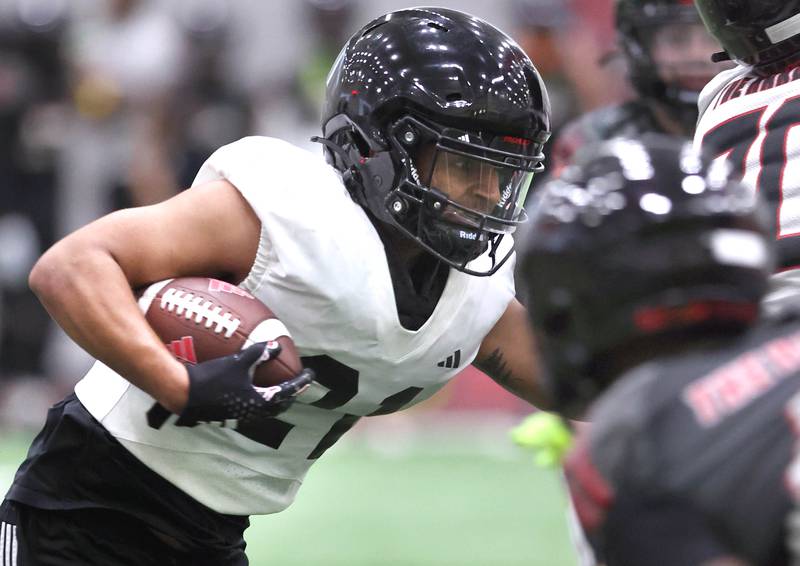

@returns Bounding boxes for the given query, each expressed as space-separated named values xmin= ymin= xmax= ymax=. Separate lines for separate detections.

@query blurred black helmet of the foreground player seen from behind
xmin=520 ymin=134 xmax=774 ymax=416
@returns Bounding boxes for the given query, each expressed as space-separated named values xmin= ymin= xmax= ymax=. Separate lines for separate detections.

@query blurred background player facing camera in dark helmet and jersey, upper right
xmin=550 ymin=0 xmax=719 ymax=175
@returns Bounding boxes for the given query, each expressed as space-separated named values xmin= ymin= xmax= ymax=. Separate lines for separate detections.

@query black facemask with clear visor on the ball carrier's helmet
xmin=384 ymin=116 xmax=544 ymax=275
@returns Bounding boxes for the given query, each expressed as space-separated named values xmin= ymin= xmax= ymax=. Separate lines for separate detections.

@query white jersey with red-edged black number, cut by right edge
xmin=694 ymin=66 xmax=800 ymax=316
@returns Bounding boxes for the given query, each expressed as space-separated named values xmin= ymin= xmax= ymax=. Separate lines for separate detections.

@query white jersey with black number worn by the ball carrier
xmin=76 ymin=137 xmax=514 ymax=515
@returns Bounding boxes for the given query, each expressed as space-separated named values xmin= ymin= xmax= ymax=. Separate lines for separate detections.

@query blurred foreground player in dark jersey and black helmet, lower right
xmin=521 ymin=135 xmax=800 ymax=566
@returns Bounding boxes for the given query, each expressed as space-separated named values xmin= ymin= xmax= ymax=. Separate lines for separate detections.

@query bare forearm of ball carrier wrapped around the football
xmin=29 ymin=238 xmax=188 ymax=410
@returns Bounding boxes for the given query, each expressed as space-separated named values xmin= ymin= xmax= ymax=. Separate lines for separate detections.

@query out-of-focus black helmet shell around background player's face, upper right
xmin=615 ymin=0 xmax=714 ymax=132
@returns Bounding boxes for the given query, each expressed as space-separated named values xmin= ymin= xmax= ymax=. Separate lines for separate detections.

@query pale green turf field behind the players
xmin=0 ymin=430 xmax=575 ymax=566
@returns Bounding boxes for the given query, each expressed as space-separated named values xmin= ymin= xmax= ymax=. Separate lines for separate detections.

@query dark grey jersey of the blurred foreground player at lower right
xmin=566 ymin=318 xmax=800 ymax=566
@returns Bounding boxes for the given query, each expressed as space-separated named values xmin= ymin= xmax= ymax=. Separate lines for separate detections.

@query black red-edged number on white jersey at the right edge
xmin=701 ymin=96 xmax=800 ymax=268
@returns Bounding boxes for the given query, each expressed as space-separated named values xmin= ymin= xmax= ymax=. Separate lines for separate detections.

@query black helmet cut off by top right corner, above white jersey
xmin=695 ymin=0 xmax=800 ymax=75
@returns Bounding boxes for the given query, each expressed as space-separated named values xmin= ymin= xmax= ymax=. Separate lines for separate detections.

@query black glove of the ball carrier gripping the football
xmin=147 ymin=341 xmax=314 ymax=430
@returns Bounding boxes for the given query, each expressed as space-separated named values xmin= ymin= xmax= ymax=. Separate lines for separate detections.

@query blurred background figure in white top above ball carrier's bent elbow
xmin=58 ymin=0 xmax=187 ymax=226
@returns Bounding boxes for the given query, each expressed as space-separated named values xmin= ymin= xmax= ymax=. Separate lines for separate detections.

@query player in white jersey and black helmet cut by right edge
xmin=695 ymin=0 xmax=800 ymax=316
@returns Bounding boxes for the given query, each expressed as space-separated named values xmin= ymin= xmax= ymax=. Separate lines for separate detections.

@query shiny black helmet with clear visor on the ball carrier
xmin=313 ymin=8 xmax=550 ymax=275
